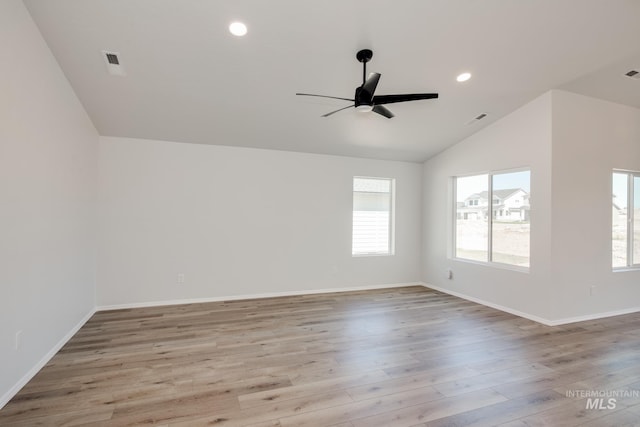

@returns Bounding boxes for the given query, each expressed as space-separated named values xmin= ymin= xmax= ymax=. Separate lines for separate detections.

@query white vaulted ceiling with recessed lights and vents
xmin=25 ymin=0 xmax=640 ymax=161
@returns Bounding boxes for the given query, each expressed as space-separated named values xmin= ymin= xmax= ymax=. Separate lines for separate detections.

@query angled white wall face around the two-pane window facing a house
xmin=422 ymin=93 xmax=551 ymax=319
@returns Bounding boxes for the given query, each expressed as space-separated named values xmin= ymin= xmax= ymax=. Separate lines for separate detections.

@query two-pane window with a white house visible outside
xmin=454 ymin=170 xmax=531 ymax=268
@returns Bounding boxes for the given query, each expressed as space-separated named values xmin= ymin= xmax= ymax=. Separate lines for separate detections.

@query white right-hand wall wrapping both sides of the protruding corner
xmin=423 ymin=91 xmax=640 ymax=323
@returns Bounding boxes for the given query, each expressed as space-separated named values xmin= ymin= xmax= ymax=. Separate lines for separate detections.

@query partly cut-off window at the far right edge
xmin=611 ymin=171 xmax=640 ymax=268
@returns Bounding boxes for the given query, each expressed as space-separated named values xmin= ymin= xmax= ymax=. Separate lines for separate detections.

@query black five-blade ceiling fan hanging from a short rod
xmin=296 ymin=49 xmax=438 ymax=119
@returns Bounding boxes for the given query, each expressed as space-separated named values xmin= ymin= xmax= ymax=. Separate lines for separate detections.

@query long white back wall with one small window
xmin=97 ymin=137 xmax=422 ymax=306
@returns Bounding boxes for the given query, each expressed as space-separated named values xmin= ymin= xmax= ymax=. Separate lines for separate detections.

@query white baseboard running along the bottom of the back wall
xmin=96 ymin=282 xmax=423 ymax=311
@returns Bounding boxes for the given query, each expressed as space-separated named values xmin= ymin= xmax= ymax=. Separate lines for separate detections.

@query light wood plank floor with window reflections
xmin=0 ymin=287 xmax=640 ymax=427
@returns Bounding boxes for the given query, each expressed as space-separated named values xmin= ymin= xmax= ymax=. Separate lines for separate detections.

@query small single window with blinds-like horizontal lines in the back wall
xmin=352 ymin=177 xmax=395 ymax=255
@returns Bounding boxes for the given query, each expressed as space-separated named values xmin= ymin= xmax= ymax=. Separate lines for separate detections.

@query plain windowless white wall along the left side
xmin=0 ymin=0 xmax=98 ymax=407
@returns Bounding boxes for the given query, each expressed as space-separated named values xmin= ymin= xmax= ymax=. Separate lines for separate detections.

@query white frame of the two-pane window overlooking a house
xmin=450 ymin=167 xmax=532 ymax=273
